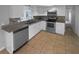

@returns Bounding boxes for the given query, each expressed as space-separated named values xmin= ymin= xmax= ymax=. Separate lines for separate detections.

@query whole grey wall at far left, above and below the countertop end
xmin=0 ymin=5 xmax=9 ymax=49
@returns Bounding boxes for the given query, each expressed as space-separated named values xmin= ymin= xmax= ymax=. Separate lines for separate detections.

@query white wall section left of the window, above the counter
xmin=10 ymin=5 xmax=24 ymax=18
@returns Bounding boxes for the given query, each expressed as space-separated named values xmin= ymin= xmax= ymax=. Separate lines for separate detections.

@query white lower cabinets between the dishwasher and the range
xmin=29 ymin=21 xmax=46 ymax=39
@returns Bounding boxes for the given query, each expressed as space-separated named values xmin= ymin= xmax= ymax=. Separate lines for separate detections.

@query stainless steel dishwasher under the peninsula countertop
xmin=13 ymin=27 xmax=28 ymax=51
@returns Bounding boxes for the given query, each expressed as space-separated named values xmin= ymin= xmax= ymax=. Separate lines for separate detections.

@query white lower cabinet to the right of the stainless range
xmin=56 ymin=22 xmax=65 ymax=35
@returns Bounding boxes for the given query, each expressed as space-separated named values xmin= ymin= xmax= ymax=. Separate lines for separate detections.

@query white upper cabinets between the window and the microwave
xmin=31 ymin=5 xmax=51 ymax=16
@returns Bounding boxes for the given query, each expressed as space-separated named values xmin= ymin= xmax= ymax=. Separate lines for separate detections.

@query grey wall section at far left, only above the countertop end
xmin=0 ymin=5 xmax=9 ymax=24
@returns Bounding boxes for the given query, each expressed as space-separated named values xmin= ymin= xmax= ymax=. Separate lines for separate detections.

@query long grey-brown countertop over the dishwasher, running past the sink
xmin=2 ymin=20 xmax=42 ymax=32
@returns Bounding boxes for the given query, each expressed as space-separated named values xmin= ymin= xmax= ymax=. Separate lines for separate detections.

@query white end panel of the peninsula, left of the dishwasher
xmin=5 ymin=31 xmax=13 ymax=53
